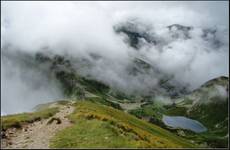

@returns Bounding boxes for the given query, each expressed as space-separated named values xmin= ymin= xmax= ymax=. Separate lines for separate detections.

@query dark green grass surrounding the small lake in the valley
xmin=126 ymin=96 xmax=228 ymax=148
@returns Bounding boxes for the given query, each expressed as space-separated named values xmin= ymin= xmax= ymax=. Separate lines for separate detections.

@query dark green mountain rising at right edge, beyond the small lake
xmin=172 ymin=76 xmax=229 ymax=147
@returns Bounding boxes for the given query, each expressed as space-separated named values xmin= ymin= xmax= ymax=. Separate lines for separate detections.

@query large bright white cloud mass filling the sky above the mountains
xmin=1 ymin=1 xmax=229 ymax=114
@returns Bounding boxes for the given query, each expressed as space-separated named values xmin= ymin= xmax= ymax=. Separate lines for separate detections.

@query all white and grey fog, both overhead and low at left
xmin=1 ymin=1 xmax=229 ymax=114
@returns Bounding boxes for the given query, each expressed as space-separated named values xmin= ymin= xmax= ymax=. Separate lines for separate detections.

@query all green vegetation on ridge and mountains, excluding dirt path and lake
xmin=1 ymin=56 xmax=228 ymax=148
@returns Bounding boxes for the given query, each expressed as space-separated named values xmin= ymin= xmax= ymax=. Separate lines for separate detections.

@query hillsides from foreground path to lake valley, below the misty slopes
xmin=2 ymin=74 xmax=228 ymax=148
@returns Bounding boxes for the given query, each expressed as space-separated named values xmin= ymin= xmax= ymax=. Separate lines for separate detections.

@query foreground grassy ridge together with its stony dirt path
xmin=2 ymin=100 xmax=195 ymax=148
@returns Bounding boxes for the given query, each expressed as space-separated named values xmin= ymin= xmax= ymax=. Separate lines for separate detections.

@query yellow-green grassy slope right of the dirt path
xmin=50 ymin=101 xmax=193 ymax=148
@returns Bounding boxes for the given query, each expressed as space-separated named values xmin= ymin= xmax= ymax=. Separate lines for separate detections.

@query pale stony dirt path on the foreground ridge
xmin=2 ymin=102 xmax=74 ymax=149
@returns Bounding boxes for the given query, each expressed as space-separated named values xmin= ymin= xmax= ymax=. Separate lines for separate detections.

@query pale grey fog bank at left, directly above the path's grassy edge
xmin=1 ymin=51 xmax=63 ymax=114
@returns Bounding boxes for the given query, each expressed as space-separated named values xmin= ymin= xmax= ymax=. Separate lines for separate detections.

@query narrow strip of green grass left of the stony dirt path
xmin=1 ymin=108 xmax=58 ymax=130
